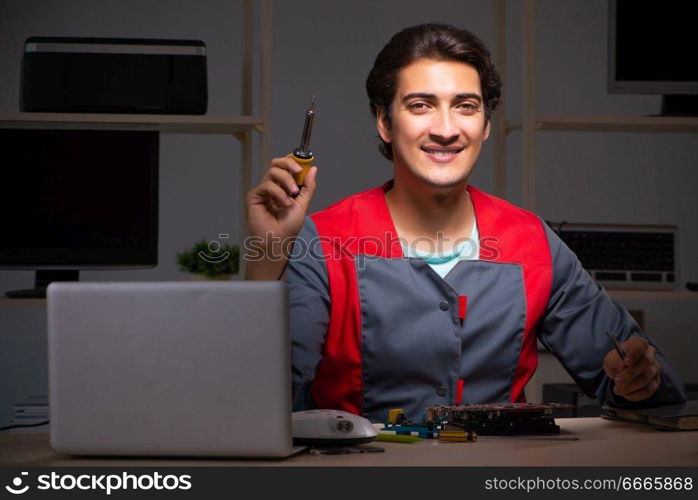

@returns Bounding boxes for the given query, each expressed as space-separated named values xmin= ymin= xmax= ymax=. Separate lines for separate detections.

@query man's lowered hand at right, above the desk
xmin=603 ymin=337 xmax=662 ymax=401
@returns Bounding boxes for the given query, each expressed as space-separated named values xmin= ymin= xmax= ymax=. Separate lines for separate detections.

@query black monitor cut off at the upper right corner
xmin=608 ymin=0 xmax=698 ymax=115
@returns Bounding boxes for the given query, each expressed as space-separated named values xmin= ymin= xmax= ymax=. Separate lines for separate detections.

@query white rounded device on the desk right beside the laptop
xmin=292 ymin=410 xmax=378 ymax=445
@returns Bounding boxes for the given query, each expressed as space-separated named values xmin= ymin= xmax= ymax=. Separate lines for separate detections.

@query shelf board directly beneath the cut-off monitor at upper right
xmin=506 ymin=115 xmax=698 ymax=133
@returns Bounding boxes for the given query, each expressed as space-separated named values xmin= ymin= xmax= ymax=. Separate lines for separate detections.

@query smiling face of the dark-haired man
xmin=378 ymin=59 xmax=490 ymax=188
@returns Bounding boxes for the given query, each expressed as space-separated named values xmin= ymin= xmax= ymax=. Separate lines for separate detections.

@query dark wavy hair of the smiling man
xmin=366 ymin=23 xmax=502 ymax=160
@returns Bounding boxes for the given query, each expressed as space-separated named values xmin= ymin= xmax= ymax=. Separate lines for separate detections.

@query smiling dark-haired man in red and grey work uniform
xmin=247 ymin=24 xmax=685 ymax=421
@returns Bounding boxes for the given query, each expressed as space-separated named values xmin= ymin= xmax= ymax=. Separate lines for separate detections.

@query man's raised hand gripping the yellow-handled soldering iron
xmin=245 ymin=156 xmax=317 ymax=280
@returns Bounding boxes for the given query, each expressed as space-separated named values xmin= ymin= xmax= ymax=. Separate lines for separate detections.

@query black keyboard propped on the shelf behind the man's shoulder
xmin=551 ymin=223 xmax=678 ymax=290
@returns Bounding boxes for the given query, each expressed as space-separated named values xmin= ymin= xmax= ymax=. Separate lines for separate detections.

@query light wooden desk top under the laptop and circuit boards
xmin=0 ymin=418 xmax=698 ymax=467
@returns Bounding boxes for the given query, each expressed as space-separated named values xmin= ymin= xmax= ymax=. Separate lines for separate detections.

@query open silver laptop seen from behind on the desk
xmin=47 ymin=281 xmax=297 ymax=457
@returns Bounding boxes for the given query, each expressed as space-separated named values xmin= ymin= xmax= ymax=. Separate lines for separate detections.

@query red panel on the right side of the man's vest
xmin=468 ymin=186 xmax=552 ymax=402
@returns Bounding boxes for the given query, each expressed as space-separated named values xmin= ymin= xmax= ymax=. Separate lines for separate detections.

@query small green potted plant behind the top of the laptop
xmin=177 ymin=238 xmax=240 ymax=280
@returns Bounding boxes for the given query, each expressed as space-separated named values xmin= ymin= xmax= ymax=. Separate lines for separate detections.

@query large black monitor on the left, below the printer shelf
xmin=0 ymin=128 xmax=159 ymax=297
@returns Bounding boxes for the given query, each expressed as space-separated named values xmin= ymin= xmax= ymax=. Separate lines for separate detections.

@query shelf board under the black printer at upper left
xmin=0 ymin=113 xmax=263 ymax=134
